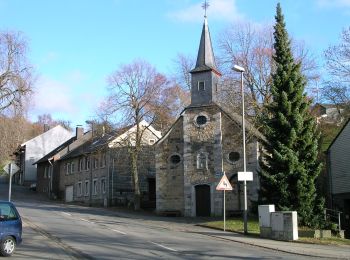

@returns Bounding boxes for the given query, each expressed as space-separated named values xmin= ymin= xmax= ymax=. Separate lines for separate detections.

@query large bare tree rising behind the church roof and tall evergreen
xmin=218 ymin=23 xmax=318 ymax=115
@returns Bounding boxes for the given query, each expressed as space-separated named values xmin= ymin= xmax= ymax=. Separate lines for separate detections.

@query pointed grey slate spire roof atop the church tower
xmin=191 ymin=16 xmax=220 ymax=74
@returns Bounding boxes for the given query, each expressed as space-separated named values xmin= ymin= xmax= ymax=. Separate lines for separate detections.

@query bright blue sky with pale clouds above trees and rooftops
xmin=0 ymin=0 xmax=350 ymax=127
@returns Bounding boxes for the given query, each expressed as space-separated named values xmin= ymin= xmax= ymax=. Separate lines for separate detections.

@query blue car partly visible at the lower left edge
xmin=0 ymin=201 xmax=22 ymax=256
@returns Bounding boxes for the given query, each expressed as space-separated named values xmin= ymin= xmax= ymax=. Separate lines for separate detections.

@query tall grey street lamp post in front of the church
xmin=232 ymin=65 xmax=248 ymax=234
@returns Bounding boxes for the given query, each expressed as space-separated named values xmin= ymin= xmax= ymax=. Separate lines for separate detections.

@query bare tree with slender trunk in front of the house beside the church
xmin=104 ymin=60 xmax=167 ymax=210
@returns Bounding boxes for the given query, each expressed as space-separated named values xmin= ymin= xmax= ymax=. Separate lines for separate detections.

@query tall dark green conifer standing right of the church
xmin=260 ymin=4 xmax=322 ymax=226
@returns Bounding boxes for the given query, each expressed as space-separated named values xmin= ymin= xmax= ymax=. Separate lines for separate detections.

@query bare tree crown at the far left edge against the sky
xmin=0 ymin=32 xmax=33 ymax=113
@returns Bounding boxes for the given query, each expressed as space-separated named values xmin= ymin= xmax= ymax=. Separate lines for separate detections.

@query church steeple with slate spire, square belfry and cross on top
xmin=190 ymin=1 xmax=221 ymax=106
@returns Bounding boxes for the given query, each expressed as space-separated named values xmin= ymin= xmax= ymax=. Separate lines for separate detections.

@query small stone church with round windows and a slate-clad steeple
xmin=156 ymin=16 xmax=261 ymax=217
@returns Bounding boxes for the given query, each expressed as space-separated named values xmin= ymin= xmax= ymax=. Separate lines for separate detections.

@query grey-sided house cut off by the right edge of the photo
xmin=327 ymin=119 xmax=350 ymax=237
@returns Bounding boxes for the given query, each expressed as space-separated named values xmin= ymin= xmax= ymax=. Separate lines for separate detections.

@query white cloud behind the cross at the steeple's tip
xmin=168 ymin=0 xmax=244 ymax=22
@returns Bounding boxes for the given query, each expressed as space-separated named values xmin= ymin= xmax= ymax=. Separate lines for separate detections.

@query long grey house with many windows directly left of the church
xmin=57 ymin=121 xmax=161 ymax=208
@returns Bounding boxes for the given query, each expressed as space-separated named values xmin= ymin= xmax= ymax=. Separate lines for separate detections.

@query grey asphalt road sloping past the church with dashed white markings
xmin=0 ymin=184 xmax=318 ymax=259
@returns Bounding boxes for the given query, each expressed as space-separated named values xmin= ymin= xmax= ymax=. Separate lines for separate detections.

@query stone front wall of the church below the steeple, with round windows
xmin=156 ymin=104 xmax=259 ymax=217
